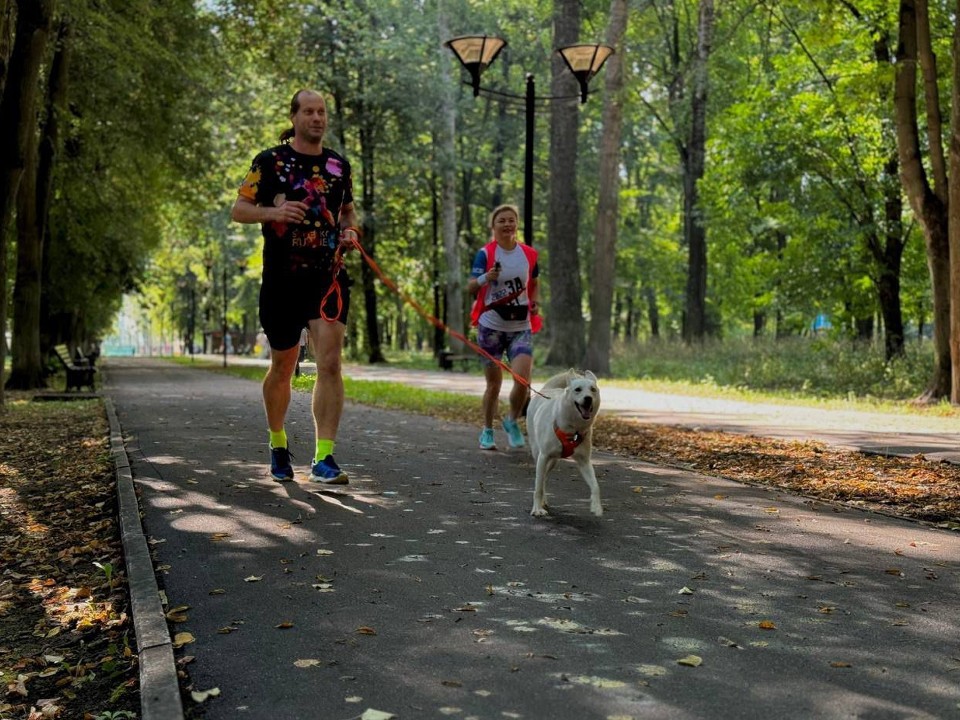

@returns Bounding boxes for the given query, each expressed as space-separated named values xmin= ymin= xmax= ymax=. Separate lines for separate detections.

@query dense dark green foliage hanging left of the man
xmin=44 ymin=0 xmax=219 ymax=342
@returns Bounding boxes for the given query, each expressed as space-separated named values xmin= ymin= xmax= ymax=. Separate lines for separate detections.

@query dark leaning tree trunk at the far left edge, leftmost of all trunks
xmin=0 ymin=0 xmax=56 ymax=405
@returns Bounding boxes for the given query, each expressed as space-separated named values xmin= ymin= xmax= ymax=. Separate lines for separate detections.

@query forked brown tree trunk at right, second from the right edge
xmin=893 ymin=0 xmax=952 ymax=401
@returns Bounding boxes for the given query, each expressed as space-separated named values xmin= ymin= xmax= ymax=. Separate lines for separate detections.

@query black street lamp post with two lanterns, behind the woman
xmin=443 ymin=35 xmax=613 ymax=245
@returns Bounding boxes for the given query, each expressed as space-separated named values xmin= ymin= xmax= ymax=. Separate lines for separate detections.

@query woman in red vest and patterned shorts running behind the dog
xmin=467 ymin=205 xmax=542 ymax=450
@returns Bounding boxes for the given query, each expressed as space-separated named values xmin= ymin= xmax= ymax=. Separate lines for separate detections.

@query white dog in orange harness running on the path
xmin=527 ymin=370 xmax=603 ymax=517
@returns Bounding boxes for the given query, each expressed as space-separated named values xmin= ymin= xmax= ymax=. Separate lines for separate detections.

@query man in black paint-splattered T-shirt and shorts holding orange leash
xmin=230 ymin=90 xmax=360 ymax=485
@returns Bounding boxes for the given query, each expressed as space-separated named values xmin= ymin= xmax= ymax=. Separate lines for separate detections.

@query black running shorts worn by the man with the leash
xmin=260 ymin=269 xmax=351 ymax=350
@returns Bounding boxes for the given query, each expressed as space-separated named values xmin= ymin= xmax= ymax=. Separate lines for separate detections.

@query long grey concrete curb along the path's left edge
xmin=104 ymin=397 xmax=183 ymax=720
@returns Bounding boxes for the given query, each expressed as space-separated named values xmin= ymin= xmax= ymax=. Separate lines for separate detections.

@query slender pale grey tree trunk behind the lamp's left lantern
xmin=436 ymin=5 xmax=469 ymax=354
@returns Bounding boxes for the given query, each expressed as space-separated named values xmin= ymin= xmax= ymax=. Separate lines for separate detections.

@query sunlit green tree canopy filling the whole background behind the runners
xmin=0 ymin=0 xmax=956 ymax=394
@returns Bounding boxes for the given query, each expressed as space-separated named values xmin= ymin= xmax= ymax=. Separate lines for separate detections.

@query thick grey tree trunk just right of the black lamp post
xmin=548 ymin=0 xmax=585 ymax=367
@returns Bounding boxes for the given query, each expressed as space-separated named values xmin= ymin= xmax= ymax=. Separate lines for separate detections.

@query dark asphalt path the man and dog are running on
xmin=104 ymin=358 xmax=960 ymax=720
